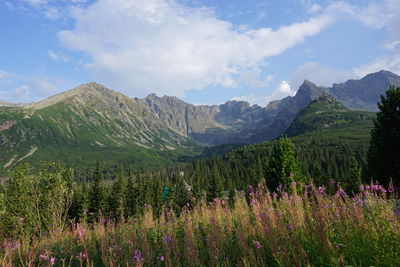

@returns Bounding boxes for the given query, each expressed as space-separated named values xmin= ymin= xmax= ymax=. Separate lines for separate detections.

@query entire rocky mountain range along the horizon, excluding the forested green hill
xmin=0 ymin=71 xmax=400 ymax=172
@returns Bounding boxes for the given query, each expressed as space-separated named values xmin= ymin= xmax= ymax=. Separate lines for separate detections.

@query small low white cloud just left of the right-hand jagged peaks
xmin=290 ymin=62 xmax=359 ymax=90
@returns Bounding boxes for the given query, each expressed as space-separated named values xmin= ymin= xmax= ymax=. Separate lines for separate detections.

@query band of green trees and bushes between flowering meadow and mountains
xmin=0 ymin=137 xmax=364 ymax=241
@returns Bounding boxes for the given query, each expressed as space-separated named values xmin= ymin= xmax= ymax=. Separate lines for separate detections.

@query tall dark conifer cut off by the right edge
xmin=368 ymin=87 xmax=400 ymax=185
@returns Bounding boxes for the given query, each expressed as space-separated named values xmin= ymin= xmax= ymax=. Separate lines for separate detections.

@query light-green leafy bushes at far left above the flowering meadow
xmin=0 ymin=163 xmax=74 ymax=239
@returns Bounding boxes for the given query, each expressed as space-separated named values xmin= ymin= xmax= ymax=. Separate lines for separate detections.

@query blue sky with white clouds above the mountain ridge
xmin=0 ymin=0 xmax=400 ymax=106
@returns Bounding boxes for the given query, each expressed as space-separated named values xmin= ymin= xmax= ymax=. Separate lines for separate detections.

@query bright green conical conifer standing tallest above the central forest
xmin=266 ymin=136 xmax=304 ymax=189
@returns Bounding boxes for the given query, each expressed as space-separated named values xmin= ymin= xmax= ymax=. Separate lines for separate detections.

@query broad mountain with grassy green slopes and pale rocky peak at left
xmin=0 ymin=83 xmax=201 ymax=176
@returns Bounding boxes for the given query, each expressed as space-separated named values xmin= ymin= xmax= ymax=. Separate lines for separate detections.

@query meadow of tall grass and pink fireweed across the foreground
xmin=0 ymin=181 xmax=400 ymax=266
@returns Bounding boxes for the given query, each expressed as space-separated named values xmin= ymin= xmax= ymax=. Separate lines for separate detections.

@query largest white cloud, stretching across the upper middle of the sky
xmin=59 ymin=0 xmax=334 ymax=96
